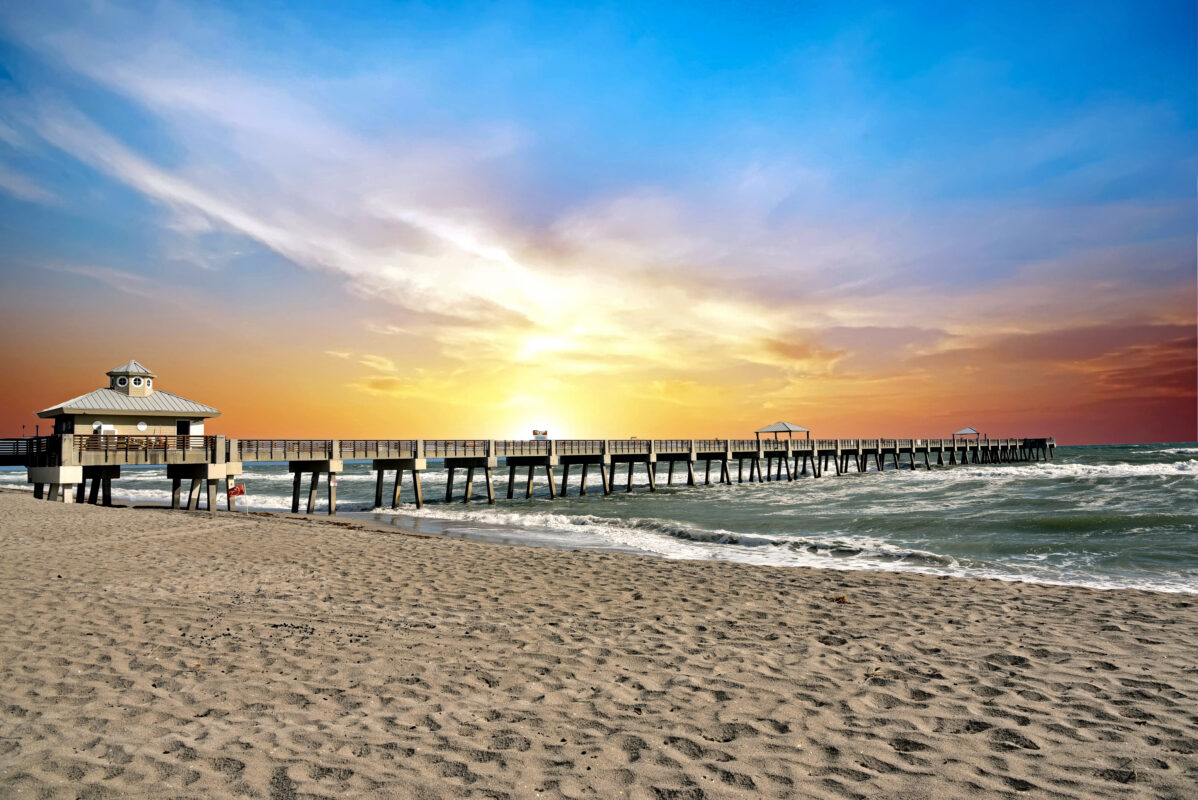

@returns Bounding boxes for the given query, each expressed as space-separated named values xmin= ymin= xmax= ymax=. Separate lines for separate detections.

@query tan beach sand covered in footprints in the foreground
xmin=0 ymin=492 xmax=1198 ymax=800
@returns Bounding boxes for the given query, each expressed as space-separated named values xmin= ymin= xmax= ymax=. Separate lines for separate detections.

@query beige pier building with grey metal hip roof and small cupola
xmin=37 ymin=360 xmax=220 ymax=436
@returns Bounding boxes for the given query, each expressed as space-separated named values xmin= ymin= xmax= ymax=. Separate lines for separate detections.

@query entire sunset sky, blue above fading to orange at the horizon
xmin=0 ymin=0 xmax=1198 ymax=443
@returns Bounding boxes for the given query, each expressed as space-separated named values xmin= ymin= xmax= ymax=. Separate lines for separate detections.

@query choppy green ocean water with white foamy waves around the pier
xmin=0 ymin=443 xmax=1198 ymax=593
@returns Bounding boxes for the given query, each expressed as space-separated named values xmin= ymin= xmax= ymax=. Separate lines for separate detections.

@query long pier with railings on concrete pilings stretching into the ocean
xmin=0 ymin=434 xmax=1057 ymax=514
